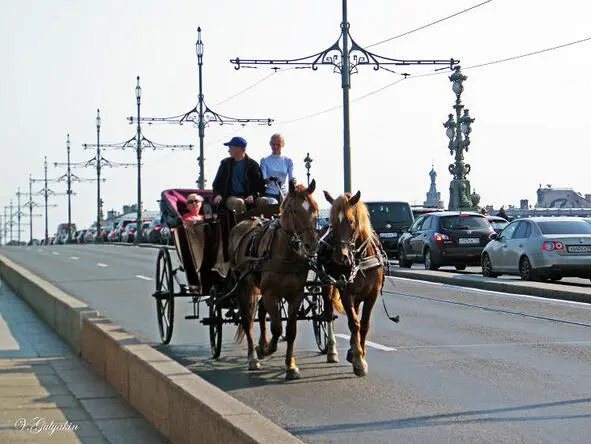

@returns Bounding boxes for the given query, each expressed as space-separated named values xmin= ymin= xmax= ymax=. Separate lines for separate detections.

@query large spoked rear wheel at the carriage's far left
xmin=156 ymin=248 xmax=174 ymax=344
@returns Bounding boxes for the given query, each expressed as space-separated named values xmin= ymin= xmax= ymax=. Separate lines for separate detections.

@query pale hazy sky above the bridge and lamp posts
xmin=0 ymin=0 xmax=591 ymax=243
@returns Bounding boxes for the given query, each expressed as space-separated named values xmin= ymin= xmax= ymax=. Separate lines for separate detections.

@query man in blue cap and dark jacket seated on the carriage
xmin=213 ymin=137 xmax=268 ymax=214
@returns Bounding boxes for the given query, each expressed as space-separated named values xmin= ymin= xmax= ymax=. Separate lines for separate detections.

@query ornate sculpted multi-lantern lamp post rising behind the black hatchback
xmin=443 ymin=66 xmax=480 ymax=210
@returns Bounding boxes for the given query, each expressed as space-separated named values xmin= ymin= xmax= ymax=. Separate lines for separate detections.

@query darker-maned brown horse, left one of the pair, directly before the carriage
xmin=229 ymin=181 xmax=318 ymax=379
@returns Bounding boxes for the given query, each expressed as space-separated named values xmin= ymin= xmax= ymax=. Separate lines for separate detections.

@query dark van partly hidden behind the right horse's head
xmin=365 ymin=201 xmax=414 ymax=257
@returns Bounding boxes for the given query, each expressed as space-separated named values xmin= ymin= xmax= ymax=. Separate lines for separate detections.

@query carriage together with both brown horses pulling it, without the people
xmin=153 ymin=181 xmax=398 ymax=379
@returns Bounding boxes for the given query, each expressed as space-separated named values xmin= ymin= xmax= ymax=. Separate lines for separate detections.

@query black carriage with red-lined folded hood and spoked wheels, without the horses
xmin=153 ymin=189 xmax=327 ymax=358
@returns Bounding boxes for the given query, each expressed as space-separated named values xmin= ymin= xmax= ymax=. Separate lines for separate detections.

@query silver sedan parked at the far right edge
xmin=482 ymin=217 xmax=591 ymax=281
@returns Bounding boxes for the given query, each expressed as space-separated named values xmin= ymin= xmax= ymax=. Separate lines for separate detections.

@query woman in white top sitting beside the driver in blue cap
xmin=261 ymin=134 xmax=293 ymax=203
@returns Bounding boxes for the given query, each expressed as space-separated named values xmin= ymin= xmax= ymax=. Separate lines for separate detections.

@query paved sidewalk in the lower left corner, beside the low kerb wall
xmin=0 ymin=281 xmax=168 ymax=443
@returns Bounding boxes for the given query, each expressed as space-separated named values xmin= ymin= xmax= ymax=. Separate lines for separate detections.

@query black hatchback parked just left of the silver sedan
xmin=398 ymin=211 xmax=494 ymax=270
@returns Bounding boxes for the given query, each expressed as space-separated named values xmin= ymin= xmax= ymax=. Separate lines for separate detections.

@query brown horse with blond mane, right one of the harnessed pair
xmin=319 ymin=191 xmax=386 ymax=376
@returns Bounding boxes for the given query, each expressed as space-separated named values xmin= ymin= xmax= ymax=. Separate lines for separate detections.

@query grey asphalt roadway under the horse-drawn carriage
xmin=0 ymin=245 xmax=591 ymax=443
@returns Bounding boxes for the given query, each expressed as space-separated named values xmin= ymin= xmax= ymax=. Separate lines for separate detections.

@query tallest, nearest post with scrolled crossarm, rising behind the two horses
xmin=230 ymin=0 xmax=459 ymax=192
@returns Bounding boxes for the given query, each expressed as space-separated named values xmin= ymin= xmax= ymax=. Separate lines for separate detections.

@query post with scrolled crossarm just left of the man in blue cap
xmin=127 ymin=27 xmax=273 ymax=190
